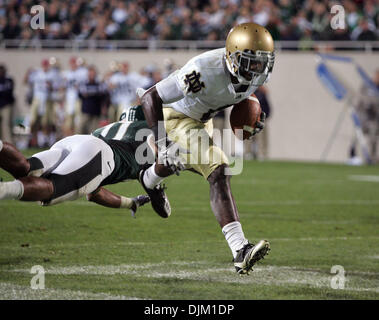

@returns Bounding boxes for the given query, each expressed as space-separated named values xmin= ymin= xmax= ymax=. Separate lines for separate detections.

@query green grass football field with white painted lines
xmin=0 ymin=152 xmax=379 ymax=300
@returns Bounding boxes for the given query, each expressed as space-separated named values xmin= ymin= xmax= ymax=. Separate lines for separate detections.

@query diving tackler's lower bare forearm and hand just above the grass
xmin=87 ymin=187 xmax=150 ymax=214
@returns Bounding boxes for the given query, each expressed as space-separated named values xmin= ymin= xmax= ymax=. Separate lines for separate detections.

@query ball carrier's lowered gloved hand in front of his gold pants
xmin=156 ymin=138 xmax=189 ymax=175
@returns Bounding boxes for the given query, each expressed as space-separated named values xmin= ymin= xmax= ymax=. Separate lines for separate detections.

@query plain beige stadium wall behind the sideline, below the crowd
xmin=0 ymin=49 xmax=379 ymax=162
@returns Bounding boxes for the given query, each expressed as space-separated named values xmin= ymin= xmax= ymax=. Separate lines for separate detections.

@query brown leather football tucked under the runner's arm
xmin=229 ymin=94 xmax=262 ymax=140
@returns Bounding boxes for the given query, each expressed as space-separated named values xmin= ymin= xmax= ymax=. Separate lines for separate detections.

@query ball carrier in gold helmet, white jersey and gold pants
xmin=139 ymin=23 xmax=274 ymax=274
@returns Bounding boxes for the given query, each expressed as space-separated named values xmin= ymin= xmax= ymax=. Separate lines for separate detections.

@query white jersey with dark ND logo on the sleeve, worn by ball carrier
xmin=156 ymin=48 xmax=257 ymax=122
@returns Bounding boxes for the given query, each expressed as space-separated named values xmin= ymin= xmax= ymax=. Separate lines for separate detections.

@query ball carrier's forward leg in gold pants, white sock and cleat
xmin=155 ymin=111 xmax=269 ymax=273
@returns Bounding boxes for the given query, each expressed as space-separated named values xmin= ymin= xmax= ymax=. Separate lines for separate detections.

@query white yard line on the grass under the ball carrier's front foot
xmin=5 ymin=261 xmax=379 ymax=293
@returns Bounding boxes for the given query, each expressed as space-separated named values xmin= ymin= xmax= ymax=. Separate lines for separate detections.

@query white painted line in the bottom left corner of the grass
xmin=0 ymin=282 xmax=145 ymax=300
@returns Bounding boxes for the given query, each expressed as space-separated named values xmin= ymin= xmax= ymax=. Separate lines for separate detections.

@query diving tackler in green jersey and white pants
xmin=0 ymin=108 xmax=156 ymax=216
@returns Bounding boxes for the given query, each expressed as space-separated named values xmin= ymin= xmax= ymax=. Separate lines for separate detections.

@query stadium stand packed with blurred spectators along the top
xmin=0 ymin=0 xmax=379 ymax=41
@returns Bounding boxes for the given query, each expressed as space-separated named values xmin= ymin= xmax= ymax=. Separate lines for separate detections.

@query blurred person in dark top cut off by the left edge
xmin=0 ymin=65 xmax=15 ymax=142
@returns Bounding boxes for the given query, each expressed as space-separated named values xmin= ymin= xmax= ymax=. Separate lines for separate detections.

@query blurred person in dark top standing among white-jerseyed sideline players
xmin=79 ymin=66 xmax=108 ymax=134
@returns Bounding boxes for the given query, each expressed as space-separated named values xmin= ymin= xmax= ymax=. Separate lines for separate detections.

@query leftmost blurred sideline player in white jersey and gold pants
xmin=25 ymin=59 xmax=54 ymax=147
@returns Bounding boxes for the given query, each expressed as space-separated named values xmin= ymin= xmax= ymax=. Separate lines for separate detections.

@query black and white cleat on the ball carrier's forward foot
xmin=234 ymin=240 xmax=270 ymax=275
